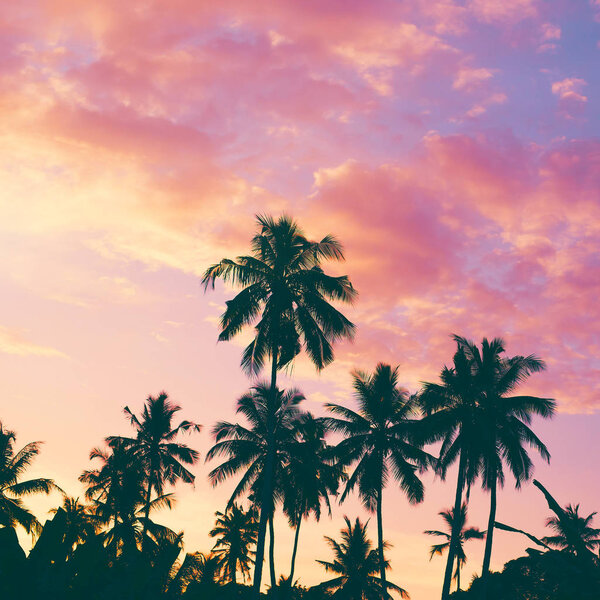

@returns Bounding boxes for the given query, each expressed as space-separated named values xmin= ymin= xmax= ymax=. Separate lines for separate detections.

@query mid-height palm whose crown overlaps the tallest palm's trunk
xmin=206 ymin=383 xmax=304 ymax=592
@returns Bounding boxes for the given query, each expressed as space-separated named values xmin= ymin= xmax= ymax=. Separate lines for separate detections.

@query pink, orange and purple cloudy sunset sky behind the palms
xmin=0 ymin=0 xmax=600 ymax=600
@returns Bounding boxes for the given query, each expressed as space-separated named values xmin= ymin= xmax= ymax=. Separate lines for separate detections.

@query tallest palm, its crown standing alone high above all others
xmin=202 ymin=215 xmax=356 ymax=597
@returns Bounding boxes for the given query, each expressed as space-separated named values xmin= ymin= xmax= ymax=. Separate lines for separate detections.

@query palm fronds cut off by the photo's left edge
xmin=0 ymin=422 xmax=62 ymax=536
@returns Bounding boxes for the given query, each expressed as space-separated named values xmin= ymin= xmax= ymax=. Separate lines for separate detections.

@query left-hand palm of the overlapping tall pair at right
xmin=419 ymin=344 xmax=480 ymax=600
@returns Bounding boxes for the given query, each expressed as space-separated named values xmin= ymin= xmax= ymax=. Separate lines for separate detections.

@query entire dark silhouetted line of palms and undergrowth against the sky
xmin=0 ymin=216 xmax=600 ymax=600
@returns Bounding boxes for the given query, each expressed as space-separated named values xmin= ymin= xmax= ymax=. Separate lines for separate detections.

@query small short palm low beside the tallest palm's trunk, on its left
xmin=209 ymin=504 xmax=258 ymax=584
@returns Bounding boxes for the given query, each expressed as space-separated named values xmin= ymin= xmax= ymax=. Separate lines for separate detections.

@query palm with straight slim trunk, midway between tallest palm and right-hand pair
xmin=325 ymin=363 xmax=433 ymax=586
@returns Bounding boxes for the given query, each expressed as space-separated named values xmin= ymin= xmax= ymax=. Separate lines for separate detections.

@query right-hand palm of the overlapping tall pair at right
xmin=455 ymin=336 xmax=556 ymax=596
